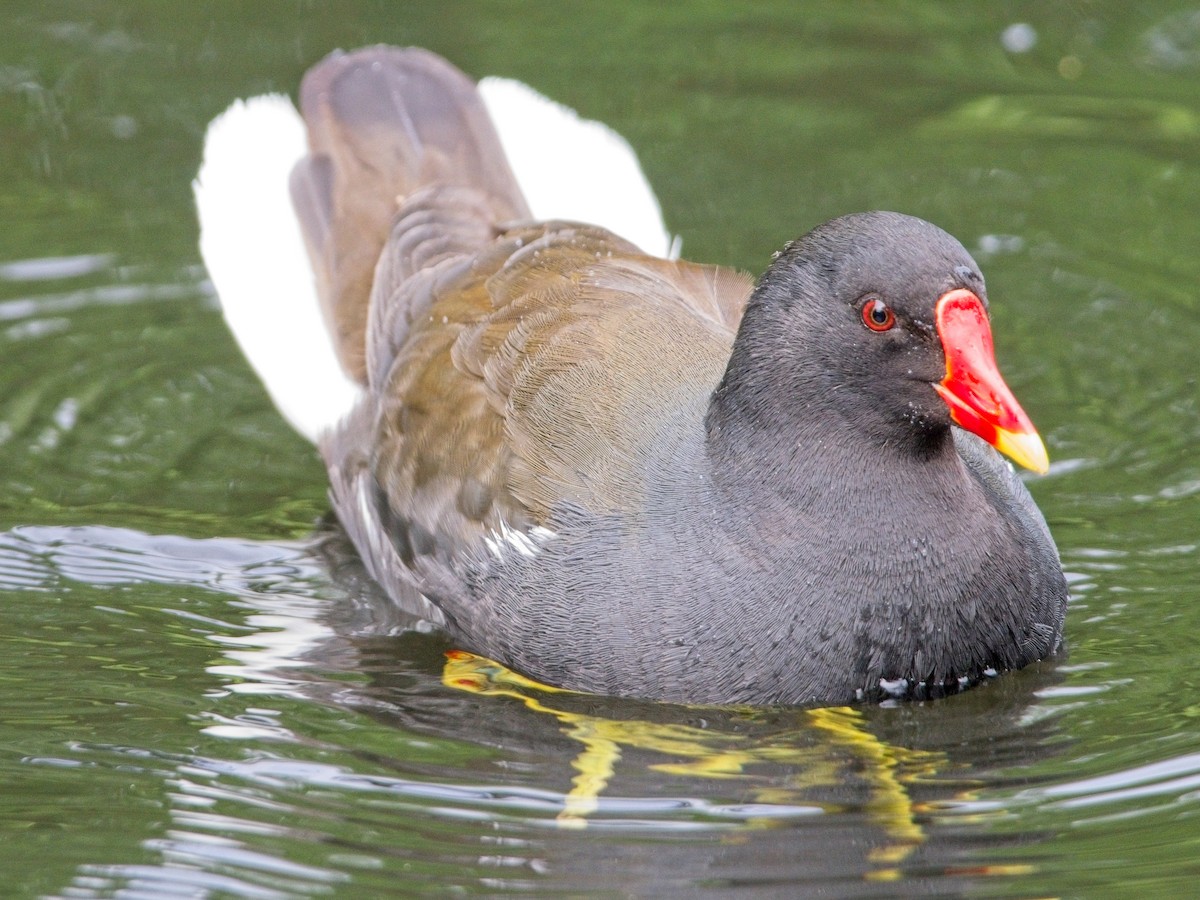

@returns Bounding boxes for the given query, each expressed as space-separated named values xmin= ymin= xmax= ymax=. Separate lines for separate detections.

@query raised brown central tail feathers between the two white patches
xmin=292 ymin=46 xmax=529 ymax=384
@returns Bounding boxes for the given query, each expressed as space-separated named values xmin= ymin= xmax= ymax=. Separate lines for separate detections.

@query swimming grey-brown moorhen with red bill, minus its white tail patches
xmin=196 ymin=47 xmax=1068 ymax=704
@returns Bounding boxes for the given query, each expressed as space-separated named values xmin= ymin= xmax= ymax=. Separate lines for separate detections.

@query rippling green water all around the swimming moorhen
xmin=0 ymin=0 xmax=1200 ymax=898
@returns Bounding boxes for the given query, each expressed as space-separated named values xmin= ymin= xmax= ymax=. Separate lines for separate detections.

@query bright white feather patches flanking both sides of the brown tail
xmin=199 ymin=78 xmax=679 ymax=443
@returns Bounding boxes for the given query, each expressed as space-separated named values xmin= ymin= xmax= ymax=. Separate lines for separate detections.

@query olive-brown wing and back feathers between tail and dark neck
xmin=357 ymin=215 xmax=751 ymax=562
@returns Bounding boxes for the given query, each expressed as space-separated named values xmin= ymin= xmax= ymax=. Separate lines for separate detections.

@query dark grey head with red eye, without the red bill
xmin=719 ymin=212 xmax=986 ymax=458
